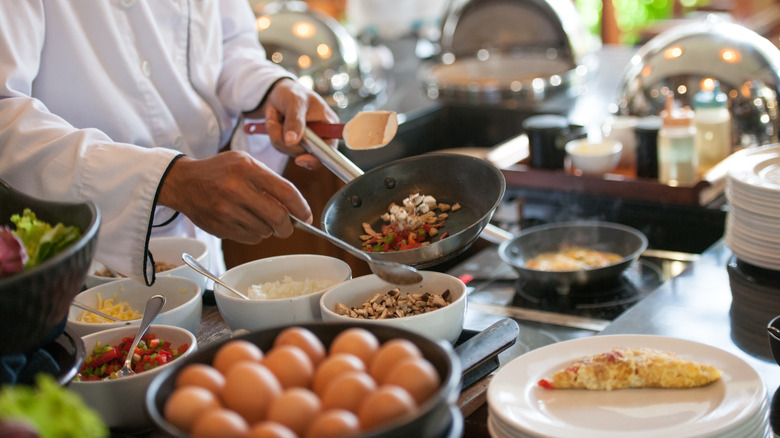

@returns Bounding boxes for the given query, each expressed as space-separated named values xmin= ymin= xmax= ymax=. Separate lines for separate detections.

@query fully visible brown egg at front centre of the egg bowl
xmin=267 ymin=388 xmax=321 ymax=436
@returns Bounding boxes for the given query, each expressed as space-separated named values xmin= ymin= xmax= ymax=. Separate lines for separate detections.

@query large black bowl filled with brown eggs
xmin=146 ymin=322 xmax=461 ymax=438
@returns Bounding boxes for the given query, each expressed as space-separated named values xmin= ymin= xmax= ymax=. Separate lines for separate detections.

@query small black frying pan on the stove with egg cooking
xmin=498 ymin=221 xmax=647 ymax=291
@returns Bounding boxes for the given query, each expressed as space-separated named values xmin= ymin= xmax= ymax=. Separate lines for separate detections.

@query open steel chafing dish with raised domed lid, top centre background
xmin=419 ymin=0 xmax=597 ymax=111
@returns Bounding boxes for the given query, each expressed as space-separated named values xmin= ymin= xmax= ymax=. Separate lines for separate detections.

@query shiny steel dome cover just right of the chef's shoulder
xmin=257 ymin=1 xmax=384 ymax=109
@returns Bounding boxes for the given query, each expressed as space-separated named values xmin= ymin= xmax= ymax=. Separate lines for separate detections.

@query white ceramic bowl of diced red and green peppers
xmin=68 ymin=325 xmax=198 ymax=432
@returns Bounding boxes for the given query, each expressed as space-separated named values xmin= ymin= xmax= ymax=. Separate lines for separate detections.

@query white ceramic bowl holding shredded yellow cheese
xmin=67 ymin=277 xmax=203 ymax=337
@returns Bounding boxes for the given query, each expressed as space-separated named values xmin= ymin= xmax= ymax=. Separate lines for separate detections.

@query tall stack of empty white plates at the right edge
xmin=725 ymin=145 xmax=780 ymax=270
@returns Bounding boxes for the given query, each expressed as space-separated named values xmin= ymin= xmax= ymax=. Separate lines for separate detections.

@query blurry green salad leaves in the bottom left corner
xmin=0 ymin=374 xmax=109 ymax=438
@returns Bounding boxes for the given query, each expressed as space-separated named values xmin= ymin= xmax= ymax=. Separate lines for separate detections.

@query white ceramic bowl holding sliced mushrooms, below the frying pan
xmin=320 ymin=271 xmax=467 ymax=344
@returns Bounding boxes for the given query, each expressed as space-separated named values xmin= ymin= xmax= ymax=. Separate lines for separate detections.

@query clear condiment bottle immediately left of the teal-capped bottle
xmin=658 ymin=95 xmax=698 ymax=186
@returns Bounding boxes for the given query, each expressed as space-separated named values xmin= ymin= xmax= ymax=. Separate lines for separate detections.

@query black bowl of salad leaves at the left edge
xmin=0 ymin=180 xmax=100 ymax=356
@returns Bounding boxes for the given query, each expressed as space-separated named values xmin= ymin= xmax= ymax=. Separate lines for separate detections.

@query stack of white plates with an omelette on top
xmin=487 ymin=335 xmax=773 ymax=438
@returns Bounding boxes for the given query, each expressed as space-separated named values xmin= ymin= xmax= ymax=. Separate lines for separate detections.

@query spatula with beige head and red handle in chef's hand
xmin=244 ymin=111 xmax=398 ymax=150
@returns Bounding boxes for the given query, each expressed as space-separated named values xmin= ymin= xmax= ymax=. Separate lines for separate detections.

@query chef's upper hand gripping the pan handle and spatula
xmin=246 ymin=79 xmax=338 ymax=169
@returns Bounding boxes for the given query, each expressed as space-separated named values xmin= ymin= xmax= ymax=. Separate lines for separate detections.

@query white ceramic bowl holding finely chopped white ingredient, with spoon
xmin=214 ymin=254 xmax=352 ymax=331
